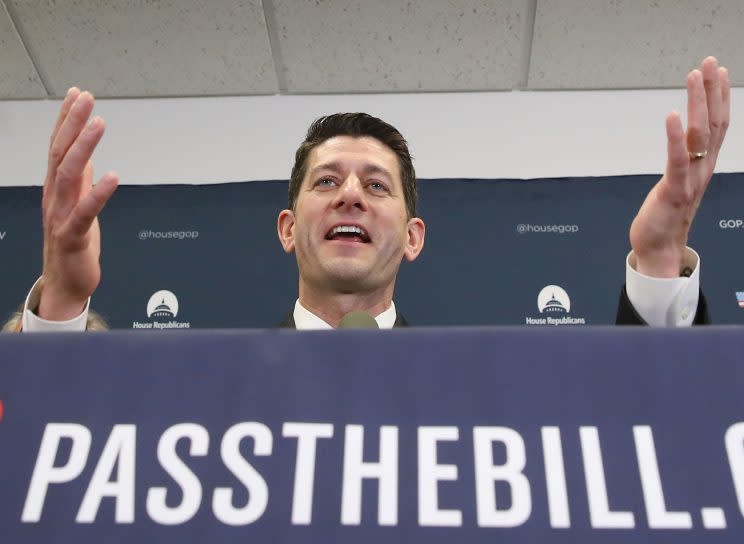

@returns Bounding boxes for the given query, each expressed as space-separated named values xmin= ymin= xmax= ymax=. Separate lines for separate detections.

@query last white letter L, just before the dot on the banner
xmin=633 ymin=425 xmax=692 ymax=529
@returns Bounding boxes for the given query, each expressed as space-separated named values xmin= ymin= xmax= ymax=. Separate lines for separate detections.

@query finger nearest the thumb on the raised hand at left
xmin=54 ymin=117 xmax=105 ymax=215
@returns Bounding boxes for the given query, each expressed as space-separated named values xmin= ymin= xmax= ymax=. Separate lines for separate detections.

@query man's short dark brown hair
xmin=289 ymin=113 xmax=418 ymax=218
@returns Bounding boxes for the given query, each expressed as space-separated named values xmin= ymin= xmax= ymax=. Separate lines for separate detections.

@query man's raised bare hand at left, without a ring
xmin=37 ymin=87 xmax=119 ymax=321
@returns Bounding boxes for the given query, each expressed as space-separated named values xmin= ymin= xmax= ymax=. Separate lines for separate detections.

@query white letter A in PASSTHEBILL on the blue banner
xmin=75 ymin=425 xmax=137 ymax=523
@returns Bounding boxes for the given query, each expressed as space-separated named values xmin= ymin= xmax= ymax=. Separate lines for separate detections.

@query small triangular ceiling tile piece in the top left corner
xmin=0 ymin=2 xmax=46 ymax=99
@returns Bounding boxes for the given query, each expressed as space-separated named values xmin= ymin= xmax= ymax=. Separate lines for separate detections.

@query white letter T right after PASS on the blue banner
xmin=282 ymin=423 xmax=333 ymax=525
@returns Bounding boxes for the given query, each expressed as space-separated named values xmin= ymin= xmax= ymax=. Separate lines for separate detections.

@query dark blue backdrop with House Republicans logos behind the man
xmin=0 ymin=174 xmax=744 ymax=328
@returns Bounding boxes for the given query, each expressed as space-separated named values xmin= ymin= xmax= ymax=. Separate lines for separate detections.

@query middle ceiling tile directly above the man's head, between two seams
xmin=273 ymin=0 xmax=527 ymax=93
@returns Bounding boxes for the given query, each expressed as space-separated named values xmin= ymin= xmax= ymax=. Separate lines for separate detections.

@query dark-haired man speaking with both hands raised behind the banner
xmin=17 ymin=57 xmax=729 ymax=330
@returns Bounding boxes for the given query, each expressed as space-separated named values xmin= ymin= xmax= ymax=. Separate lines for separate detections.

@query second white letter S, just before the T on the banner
xmin=212 ymin=422 xmax=272 ymax=525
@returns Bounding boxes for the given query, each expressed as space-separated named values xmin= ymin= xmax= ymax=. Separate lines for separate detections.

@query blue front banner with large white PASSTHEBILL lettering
xmin=0 ymin=327 xmax=744 ymax=544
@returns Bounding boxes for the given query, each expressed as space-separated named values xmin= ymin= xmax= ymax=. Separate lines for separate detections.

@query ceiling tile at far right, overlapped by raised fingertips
xmin=528 ymin=0 xmax=744 ymax=89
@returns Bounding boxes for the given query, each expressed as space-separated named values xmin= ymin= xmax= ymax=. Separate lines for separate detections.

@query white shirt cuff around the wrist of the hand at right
xmin=625 ymin=247 xmax=700 ymax=327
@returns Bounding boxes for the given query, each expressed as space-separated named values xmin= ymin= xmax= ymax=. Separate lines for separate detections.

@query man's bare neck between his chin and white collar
xmin=299 ymin=282 xmax=393 ymax=328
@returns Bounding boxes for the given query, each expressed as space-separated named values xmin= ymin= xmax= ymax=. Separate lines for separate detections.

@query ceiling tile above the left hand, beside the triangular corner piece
xmin=6 ymin=0 xmax=277 ymax=96
